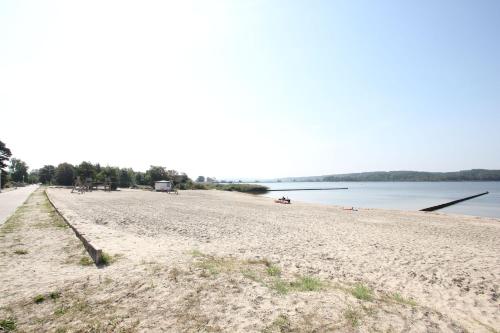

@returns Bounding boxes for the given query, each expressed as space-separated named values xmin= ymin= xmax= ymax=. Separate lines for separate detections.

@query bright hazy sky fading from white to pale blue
xmin=0 ymin=0 xmax=500 ymax=179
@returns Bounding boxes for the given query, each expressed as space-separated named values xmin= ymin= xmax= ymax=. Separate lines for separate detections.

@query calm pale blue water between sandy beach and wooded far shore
xmin=260 ymin=182 xmax=500 ymax=218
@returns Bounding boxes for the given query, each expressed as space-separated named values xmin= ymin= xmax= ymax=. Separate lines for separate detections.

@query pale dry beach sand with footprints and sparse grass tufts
xmin=0 ymin=189 xmax=500 ymax=332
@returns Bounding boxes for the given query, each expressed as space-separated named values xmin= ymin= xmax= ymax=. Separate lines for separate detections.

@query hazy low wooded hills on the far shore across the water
xmin=278 ymin=169 xmax=500 ymax=182
